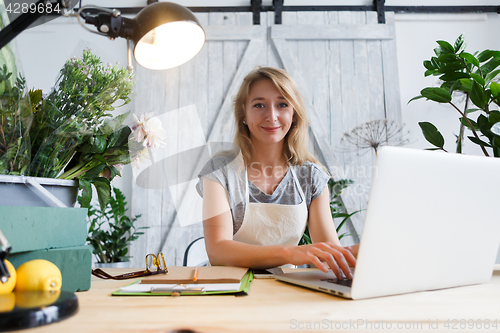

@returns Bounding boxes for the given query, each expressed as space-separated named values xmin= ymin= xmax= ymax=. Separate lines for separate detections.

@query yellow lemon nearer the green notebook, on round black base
xmin=16 ymin=259 xmax=62 ymax=291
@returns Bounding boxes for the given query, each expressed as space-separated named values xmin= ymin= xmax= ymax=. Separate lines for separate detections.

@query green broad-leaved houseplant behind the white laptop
xmin=408 ymin=35 xmax=500 ymax=157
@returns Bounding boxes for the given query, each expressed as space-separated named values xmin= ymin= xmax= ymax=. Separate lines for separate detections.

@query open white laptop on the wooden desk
xmin=275 ymin=147 xmax=500 ymax=299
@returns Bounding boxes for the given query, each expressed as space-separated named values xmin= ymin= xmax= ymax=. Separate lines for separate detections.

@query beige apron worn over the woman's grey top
xmin=233 ymin=166 xmax=308 ymax=245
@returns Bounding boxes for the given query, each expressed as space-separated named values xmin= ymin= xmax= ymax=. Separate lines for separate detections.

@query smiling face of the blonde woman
xmin=245 ymin=80 xmax=294 ymax=144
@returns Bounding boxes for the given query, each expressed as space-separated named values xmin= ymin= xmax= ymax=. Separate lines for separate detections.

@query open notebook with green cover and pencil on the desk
xmin=112 ymin=266 xmax=253 ymax=296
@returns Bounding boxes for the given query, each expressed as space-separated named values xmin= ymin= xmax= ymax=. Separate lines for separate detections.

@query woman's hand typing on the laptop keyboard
xmin=287 ymin=242 xmax=356 ymax=279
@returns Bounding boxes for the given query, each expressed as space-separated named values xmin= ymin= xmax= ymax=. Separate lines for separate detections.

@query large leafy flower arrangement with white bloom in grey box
xmin=0 ymin=49 xmax=165 ymax=209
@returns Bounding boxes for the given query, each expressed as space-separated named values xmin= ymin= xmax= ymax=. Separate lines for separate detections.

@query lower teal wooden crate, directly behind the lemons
xmin=7 ymin=245 xmax=92 ymax=292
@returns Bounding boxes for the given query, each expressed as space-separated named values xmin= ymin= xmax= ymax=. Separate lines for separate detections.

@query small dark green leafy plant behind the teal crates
xmin=87 ymin=187 xmax=147 ymax=267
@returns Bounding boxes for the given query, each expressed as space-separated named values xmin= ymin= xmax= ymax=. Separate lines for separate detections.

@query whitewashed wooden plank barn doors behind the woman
xmin=130 ymin=12 xmax=401 ymax=267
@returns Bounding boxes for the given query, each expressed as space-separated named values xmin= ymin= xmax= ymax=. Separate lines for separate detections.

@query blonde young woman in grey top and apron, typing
xmin=197 ymin=67 xmax=357 ymax=278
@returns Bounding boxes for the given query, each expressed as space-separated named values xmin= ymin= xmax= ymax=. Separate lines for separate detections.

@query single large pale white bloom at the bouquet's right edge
xmin=132 ymin=113 xmax=167 ymax=150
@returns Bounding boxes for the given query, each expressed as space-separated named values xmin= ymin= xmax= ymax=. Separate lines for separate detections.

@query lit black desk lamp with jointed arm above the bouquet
xmin=0 ymin=0 xmax=205 ymax=70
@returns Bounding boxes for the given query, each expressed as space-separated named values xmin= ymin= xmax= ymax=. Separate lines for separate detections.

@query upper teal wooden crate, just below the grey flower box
xmin=0 ymin=206 xmax=87 ymax=253
